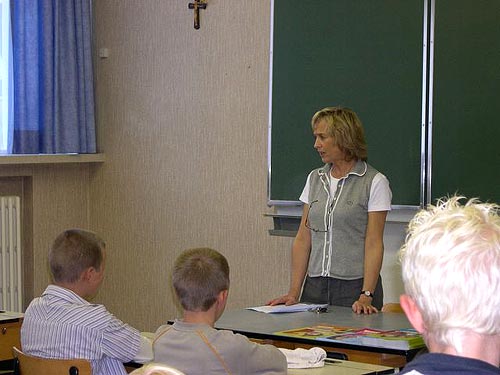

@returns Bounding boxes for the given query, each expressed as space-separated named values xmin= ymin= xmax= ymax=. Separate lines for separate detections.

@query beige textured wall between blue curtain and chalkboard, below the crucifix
xmin=90 ymin=0 xmax=291 ymax=330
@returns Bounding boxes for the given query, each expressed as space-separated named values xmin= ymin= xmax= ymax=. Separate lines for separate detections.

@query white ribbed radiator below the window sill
xmin=0 ymin=197 xmax=23 ymax=312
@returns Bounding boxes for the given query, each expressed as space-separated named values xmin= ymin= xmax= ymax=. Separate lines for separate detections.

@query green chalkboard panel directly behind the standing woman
xmin=269 ymin=0 xmax=424 ymax=206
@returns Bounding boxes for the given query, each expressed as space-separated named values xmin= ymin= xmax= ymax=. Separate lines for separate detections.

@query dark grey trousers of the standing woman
xmin=300 ymin=275 xmax=384 ymax=310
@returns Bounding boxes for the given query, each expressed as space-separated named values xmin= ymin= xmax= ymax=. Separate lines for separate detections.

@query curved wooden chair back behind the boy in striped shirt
xmin=12 ymin=346 xmax=92 ymax=375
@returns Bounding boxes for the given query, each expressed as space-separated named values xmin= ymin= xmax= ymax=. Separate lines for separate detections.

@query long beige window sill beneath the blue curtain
xmin=0 ymin=154 xmax=106 ymax=165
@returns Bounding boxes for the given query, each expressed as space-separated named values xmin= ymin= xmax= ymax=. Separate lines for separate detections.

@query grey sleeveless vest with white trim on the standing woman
xmin=307 ymin=161 xmax=378 ymax=280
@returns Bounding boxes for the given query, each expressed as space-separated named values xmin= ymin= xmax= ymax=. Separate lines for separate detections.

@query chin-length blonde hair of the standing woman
xmin=311 ymin=107 xmax=368 ymax=161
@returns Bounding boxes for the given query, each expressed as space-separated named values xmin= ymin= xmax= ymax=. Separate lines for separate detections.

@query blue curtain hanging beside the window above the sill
xmin=11 ymin=0 xmax=96 ymax=154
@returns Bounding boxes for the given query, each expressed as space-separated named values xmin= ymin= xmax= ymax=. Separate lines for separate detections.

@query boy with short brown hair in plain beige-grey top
xmin=153 ymin=248 xmax=287 ymax=374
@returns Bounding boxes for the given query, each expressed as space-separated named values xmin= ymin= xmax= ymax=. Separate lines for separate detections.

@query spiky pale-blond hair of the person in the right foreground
xmin=400 ymin=196 xmax=500 ymax=352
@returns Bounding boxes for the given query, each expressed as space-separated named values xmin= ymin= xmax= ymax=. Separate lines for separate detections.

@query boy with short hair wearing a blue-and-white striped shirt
xmin=21 ymin=229 xmax=152 ymax=375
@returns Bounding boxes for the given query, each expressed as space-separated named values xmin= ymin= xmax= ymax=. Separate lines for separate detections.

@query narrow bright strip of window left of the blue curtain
xmin=0 ymin=0 xmax=11 ymax=153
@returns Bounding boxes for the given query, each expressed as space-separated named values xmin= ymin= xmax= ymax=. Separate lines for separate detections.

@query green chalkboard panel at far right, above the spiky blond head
xmin=431 ymin=0 xmax=500 ymax=202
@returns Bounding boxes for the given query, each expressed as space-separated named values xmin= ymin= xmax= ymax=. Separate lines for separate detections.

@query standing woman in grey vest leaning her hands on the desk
xmin=269 ymin=107 xmax=392 ymax=314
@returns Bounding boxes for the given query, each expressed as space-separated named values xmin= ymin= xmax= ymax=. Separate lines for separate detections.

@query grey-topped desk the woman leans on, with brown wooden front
xmin=215 ymin=306 xmax=420 ymax=367
